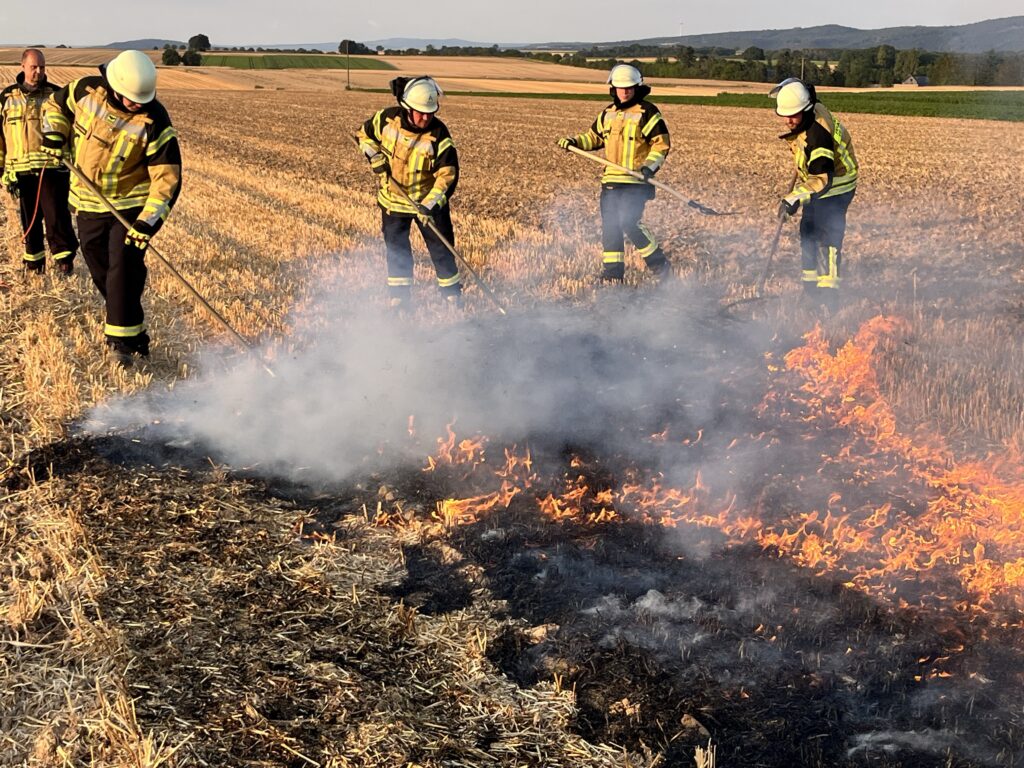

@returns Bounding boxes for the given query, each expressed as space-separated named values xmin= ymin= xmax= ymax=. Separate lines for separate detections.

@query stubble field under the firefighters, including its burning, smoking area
xmin=0 ymin=85 xmax=1024 ymax=768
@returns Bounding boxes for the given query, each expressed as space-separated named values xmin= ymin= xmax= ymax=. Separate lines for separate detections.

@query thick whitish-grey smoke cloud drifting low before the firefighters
xmin=87 ymin=274 xmax=763 ymax=482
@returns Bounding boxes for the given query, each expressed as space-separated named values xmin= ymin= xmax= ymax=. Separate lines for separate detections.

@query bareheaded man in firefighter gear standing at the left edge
xmin=0 ymin=48 xmax=78 ymax=275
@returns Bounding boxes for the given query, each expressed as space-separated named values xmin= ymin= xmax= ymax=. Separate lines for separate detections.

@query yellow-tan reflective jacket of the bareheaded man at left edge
xmin=0 ymin=72 xmax=63 ymax=173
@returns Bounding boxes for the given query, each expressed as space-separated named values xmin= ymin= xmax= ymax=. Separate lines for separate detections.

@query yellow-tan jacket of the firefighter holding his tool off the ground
xmin=575 ymin=85 xmax=672 ymax=184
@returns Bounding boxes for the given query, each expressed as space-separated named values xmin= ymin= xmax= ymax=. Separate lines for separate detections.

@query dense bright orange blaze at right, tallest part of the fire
xmin=759 ymin=317 xmax=1024 ymax=607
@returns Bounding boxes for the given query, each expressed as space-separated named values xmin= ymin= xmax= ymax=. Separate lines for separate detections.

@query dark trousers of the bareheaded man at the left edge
xmin=17 ymin=168 xmax=78 ymax=268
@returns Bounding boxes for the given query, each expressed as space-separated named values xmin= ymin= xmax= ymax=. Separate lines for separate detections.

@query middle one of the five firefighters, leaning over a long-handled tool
xmin=358 ymin=76 xmax=462 ymax=309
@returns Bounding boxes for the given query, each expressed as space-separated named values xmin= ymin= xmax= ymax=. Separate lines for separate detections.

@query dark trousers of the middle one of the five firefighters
xmin=381 ymin=206 xmax=462 ymax=298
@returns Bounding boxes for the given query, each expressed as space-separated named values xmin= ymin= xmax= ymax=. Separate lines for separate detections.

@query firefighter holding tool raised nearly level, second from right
xmin=558 ymin=63 xmax=670 ymax=283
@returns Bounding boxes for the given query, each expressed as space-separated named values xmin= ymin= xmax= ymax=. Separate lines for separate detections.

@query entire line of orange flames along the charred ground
xmin=407 ymin=316 xmax=1024 ymax=626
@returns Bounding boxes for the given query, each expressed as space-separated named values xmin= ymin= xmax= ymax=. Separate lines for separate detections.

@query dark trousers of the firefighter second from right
xmin=601 ymin=184 xmax=668 ymax=280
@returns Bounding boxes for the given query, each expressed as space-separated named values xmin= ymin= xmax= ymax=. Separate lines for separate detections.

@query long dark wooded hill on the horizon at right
xmin=529 ymin=16 xmax=1024 ymax=53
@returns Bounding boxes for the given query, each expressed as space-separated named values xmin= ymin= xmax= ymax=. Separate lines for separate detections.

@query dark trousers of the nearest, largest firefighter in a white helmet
xmin=78 ymin=208 xmax=150 ymax=351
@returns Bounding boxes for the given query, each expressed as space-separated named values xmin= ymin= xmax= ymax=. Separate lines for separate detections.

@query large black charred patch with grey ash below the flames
xmin=413 ymin=493 xmax=1024 ymax=768
